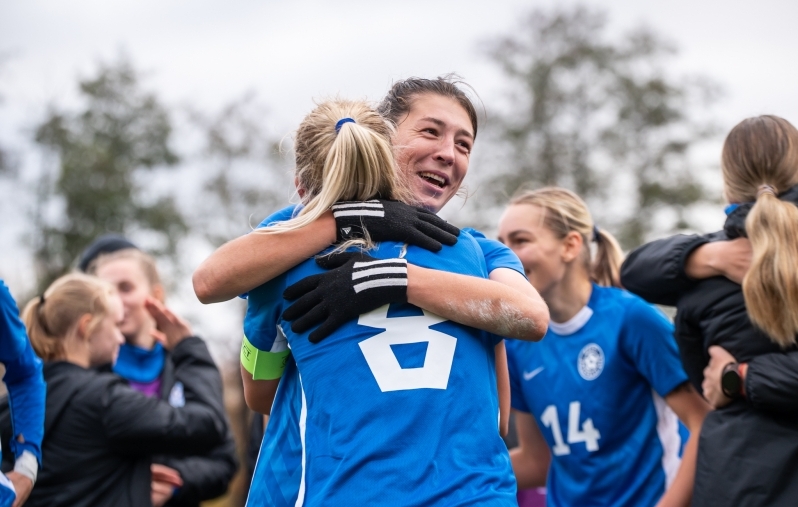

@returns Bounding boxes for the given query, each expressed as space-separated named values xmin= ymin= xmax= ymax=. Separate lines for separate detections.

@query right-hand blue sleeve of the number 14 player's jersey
xmin=620 ymin=295 xmax=687 ymax=398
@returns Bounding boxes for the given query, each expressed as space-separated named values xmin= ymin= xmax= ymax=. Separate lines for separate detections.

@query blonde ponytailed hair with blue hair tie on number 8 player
xmin=258 ymin=100 xmax=413 ymax=242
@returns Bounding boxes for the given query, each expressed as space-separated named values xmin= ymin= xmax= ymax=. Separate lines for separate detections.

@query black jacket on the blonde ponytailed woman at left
xmin=25 ymin=337 xmax=227 ymax=507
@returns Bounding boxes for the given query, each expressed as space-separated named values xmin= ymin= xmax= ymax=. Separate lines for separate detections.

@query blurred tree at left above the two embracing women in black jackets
xmin=33 ymin=57 xmax=188 ymax=289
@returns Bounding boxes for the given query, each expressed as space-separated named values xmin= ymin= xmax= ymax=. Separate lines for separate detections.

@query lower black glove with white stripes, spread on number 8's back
xmin=283 ymin=252 xmax=407 ymax=343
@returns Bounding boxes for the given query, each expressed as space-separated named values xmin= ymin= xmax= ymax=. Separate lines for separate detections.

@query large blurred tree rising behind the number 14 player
xmin=483 ymin=6 xmax=719 ymax=247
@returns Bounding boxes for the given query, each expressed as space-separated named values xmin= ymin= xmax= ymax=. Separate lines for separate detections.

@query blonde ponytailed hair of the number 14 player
xmin=510 ymin=187 xmax=623 ymax=287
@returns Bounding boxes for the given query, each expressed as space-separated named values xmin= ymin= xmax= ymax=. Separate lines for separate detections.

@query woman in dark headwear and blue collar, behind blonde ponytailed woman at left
xmin=79 ymin=235 xmax=238 ymax=507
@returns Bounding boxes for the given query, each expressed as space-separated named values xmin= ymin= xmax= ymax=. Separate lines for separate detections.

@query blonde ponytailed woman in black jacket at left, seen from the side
xmin=18 ymin=274 xmax=230 ymax=507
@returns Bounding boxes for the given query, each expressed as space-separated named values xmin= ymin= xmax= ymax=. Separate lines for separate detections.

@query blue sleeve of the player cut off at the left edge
xmin=0 ymin=280 xmax=46 ymax=464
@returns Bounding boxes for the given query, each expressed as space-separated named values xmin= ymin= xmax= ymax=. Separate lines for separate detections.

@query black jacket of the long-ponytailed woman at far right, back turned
xmin=621 ymin=188 xmax=798 ymax=507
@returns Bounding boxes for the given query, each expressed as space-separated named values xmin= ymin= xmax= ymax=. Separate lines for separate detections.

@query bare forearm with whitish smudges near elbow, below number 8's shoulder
xmin=407 ymin=265 xmax=548 ymax=341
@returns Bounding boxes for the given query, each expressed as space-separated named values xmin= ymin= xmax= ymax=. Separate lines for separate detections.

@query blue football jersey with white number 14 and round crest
xmin=507 ymin=285 xmax=687 ymax=507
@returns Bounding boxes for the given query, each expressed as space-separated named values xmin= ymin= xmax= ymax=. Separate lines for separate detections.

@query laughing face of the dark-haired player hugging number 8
xmin=394 ymin=93 xmax=474 ymax=213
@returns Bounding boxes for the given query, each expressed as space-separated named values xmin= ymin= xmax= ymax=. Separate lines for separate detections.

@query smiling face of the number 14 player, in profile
xmin=499 ymin=204 xmax=573 ymax=298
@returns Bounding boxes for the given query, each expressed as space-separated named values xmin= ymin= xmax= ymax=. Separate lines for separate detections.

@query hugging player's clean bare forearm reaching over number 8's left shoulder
xmin=198 ymin=212 xmax=335 ymax=304
